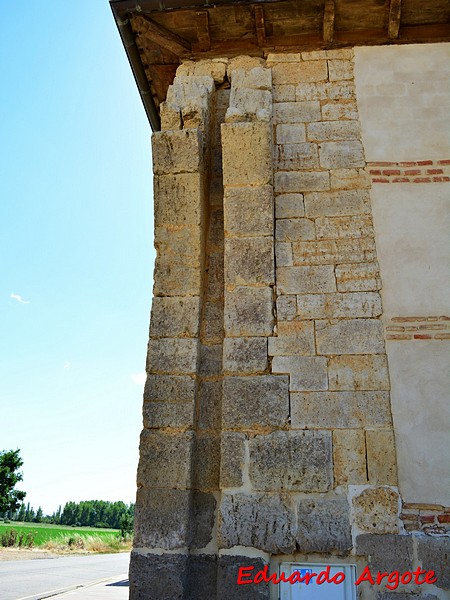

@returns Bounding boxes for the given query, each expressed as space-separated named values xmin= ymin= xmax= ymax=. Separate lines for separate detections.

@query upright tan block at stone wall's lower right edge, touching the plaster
xmin=366 ymin=429 xmax=397 ymax=485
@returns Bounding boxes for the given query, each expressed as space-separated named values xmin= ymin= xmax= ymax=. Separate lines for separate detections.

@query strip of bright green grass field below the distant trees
xmin=0 ymin=521 xmax=120 ymax=546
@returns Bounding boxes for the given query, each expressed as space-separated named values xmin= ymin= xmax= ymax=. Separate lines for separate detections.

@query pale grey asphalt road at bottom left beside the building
xmin=0 ymin=552 xmax=130 ymax=600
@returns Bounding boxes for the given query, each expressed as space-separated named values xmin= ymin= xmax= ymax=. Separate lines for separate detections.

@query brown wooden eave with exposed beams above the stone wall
xmin=110 ymin=0 xmax=450 ymax=129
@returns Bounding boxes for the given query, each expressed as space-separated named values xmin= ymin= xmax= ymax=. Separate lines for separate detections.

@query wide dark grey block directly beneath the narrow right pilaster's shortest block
xmin=222 ymin=375 xmax=289 ymax=430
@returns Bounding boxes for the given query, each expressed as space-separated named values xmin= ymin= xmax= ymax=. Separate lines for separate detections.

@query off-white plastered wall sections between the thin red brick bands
xmin=355 ymin=44 xmax=450 ymax=506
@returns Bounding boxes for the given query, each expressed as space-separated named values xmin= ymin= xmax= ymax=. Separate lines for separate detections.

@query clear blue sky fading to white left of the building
xmin=0 ymin=0 xmax=154 ymax=513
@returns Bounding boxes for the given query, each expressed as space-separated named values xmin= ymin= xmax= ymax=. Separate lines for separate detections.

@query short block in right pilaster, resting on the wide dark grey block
xmin=223 ymin=337 xmax=267 ymax=374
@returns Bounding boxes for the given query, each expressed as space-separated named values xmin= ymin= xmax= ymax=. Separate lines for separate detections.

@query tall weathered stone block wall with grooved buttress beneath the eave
xmin=130 ymin=44 xmax=448 ymax=600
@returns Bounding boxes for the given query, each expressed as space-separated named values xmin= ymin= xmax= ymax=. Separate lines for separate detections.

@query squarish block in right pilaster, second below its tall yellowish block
xmin=225 ymin=237 xmax=275 ymax=285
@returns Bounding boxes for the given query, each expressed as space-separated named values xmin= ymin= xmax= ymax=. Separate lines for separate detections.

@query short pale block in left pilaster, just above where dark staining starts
xmin=147 ymin=338 xmax=198 ymax=375
